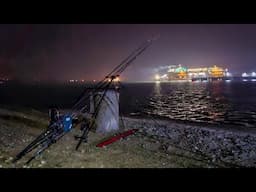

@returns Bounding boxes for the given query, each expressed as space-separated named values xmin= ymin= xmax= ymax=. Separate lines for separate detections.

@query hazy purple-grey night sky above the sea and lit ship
xmin=0 ymin=24 xmax=256 ymax=81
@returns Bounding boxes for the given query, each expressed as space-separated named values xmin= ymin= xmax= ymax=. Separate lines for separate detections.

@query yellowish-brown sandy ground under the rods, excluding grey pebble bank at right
xmin=0 ymin=108 xmax=227 ymax=168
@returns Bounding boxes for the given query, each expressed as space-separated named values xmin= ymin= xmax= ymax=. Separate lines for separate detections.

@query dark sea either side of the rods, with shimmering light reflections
xmin=0 ymin=81 xmax=256 ymax=128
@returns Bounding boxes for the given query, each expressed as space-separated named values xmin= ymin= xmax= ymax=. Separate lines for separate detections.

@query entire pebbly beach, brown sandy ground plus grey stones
xmin=0 ymin=109 xmax=256 ymax=168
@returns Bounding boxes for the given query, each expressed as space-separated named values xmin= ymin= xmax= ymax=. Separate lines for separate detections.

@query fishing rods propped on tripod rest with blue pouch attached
xmin=13 ymin=38 xmax=158 ymax=164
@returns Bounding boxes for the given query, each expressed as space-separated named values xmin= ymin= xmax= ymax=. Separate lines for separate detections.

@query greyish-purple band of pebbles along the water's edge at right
xmin=123 ymin=117 xmax=256 ymax=167
